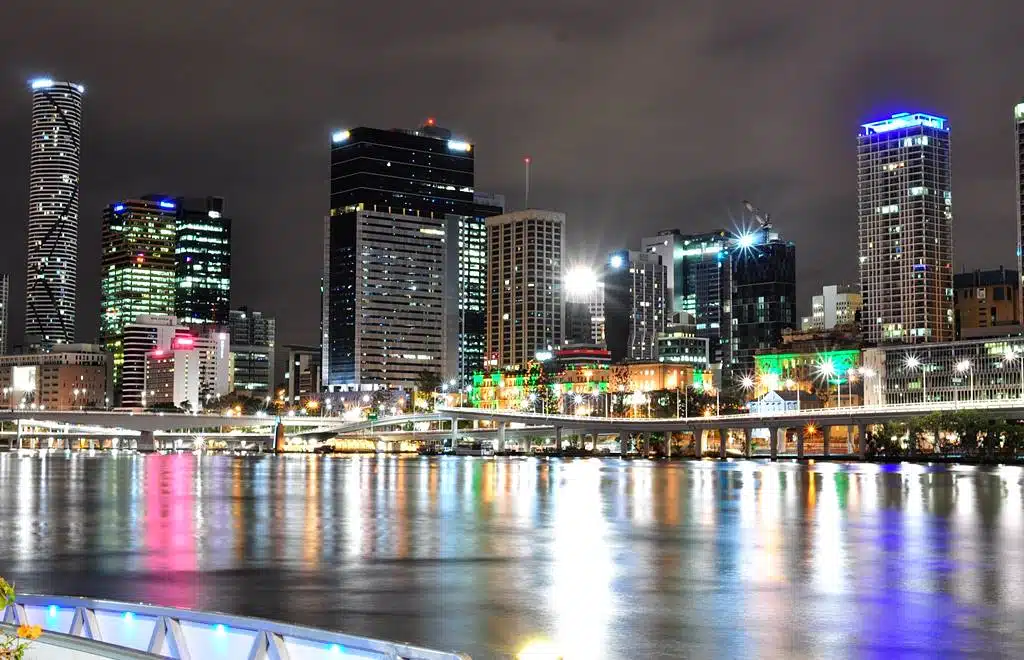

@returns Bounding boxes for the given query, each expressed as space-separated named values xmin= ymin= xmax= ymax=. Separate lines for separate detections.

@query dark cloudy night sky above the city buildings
xmin=0 ymin=0 xmax=1024 ymax=356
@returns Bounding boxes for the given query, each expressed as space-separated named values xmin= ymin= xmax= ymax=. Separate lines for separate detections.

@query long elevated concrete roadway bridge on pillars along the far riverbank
xmin=0 ymin=399 xmax=1024 ymax=458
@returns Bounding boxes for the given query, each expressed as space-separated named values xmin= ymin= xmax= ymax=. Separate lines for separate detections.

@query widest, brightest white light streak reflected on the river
xmin=542 ymin=460 xmax=610 ymax=660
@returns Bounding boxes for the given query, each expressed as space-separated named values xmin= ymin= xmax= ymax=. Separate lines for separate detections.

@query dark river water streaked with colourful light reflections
xmin=0 ymin=453 xmax=1024 ymax=660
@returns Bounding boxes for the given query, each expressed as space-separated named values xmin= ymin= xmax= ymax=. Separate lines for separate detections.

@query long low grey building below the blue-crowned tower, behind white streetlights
xmin=864 ymin=337 xmax=1024 ymax=407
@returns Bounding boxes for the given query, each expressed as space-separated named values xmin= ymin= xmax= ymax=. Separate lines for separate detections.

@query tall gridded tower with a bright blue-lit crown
xmin=857 ymin=113 xmax=953 ymax=344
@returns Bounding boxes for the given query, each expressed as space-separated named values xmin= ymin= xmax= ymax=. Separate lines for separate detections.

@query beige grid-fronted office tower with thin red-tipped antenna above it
xmin=485 ymin=209 xmax=565 ymax=368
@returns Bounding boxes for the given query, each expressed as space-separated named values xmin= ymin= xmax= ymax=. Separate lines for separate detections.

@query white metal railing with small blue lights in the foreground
xmin=0 ymin=595 xmax=469 ymax=660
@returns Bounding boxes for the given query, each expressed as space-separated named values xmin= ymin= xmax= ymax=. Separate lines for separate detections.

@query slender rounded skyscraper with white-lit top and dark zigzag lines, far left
xmin=25 ymin=79 xmax=85 ymax=346
